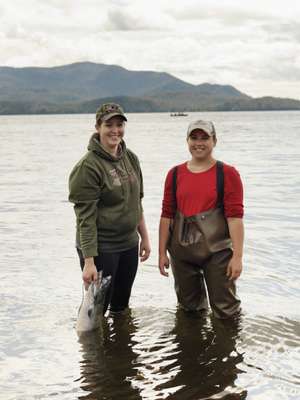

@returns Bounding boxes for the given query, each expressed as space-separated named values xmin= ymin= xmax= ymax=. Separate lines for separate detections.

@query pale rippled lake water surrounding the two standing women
xmin=0 ymin=112 xmax=300 ymax=400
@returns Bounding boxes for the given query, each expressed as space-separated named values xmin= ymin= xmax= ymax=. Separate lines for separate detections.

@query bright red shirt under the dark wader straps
xmin=161 ymin=162 xmax=244 ymax=218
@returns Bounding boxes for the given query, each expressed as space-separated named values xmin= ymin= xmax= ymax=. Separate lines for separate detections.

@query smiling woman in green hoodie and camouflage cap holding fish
xmin=69 ymin=103 xmax=150 ymax=313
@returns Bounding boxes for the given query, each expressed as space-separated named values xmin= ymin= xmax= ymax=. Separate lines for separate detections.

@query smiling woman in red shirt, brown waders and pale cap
xmin=159 ymin=120 xmax=244 ymax=318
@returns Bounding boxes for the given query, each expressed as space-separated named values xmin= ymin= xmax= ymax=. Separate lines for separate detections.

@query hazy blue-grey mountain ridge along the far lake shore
xmin=0 ymin=61 xmax=300 ymax=114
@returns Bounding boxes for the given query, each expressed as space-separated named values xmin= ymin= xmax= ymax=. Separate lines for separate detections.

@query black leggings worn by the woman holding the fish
xmin=77 ymin=245 xmax=138 ymax=314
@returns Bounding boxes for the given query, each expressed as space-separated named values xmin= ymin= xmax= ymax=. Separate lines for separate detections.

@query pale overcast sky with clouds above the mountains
xmin=0 ymin=0 xmax=300 ymax=99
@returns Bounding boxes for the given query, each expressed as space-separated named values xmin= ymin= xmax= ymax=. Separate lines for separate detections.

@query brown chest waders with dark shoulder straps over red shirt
xmin=168 ymin=161 xmax=240 ymax=318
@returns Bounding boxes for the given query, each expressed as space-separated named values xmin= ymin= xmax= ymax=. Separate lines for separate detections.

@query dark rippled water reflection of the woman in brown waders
xmin=164 ymin=311 xmax=246 ymax=400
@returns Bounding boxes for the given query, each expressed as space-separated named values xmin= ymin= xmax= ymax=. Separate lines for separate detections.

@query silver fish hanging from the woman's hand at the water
xmin=76 ymin=273 xmax=111 ymax=335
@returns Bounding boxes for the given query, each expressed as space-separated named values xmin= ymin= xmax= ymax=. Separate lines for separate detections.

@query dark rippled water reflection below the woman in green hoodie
xmin=78 ymin=311 xmax=142 ymax=400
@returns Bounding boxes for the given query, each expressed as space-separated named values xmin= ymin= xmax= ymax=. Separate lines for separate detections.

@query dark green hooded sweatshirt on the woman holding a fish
xmin=69 ymin=133 xmax=143 ymax=257
